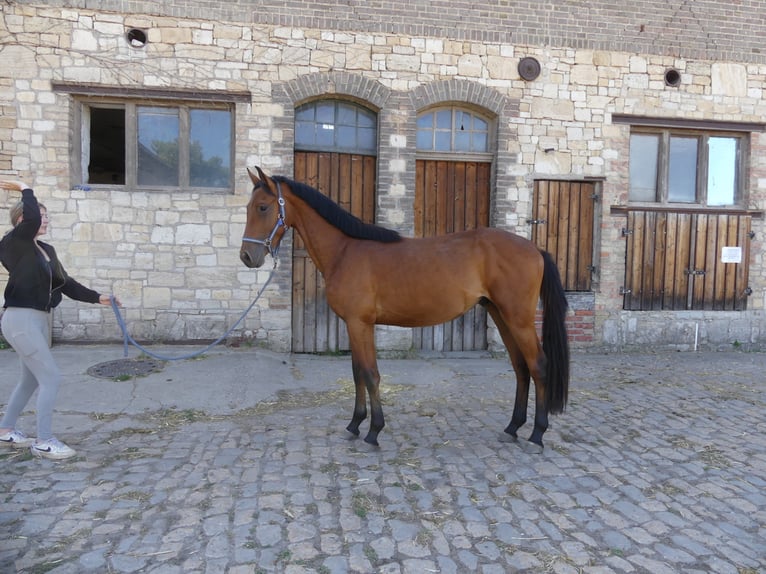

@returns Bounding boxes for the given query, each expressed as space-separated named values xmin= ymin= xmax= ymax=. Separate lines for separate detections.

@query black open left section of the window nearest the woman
xmin=88 ymin=108 xmax=125 ymax=185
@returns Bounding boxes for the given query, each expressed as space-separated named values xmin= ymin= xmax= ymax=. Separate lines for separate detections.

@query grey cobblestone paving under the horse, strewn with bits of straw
xmin=0 ymin=352 xmax=766 ymax=574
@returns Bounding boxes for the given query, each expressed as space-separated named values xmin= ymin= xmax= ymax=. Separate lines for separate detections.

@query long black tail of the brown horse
xmin=540 ymin=251 xmax=569 ymax=414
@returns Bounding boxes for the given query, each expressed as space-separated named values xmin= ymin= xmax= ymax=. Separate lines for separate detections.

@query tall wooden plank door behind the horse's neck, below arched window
xmin=292 ymin=151 xmax=376 ymax=353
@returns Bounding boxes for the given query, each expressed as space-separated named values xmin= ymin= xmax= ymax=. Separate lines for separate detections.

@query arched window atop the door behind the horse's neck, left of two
xmin=295 ymin=100 xmax=378 ymax=155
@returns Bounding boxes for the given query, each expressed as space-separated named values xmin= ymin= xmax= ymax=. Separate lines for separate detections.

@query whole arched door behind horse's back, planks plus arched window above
xmin=413 ymin=107 xmax=492 ymax=351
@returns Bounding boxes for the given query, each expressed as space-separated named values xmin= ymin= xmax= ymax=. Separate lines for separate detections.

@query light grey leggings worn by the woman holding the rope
xmin=0 ymin=307 xmax=61 ymax=441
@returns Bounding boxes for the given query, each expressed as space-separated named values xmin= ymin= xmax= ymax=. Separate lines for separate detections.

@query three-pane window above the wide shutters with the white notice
xmin=629 ymin=129 xmax=747 ymax=207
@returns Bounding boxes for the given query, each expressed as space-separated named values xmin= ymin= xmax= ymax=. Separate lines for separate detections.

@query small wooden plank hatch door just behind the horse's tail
xmin=530 ymin=180 xmax=598 ymax=291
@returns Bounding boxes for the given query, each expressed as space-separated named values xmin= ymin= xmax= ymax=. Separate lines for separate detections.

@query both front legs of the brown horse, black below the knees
xmin=346 ymin=322 xmax=386 ymax=446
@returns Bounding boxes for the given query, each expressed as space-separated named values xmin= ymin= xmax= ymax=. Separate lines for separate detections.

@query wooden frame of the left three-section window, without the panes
xmin=71 ymin=97 xmax=236 ymax=193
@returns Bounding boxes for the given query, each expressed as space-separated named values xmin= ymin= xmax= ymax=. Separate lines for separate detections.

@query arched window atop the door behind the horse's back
xmin=417 ymin=107 xmax=489 ymax=154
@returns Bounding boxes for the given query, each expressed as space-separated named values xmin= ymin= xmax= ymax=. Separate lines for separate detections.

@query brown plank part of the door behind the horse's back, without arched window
xmin=413 ymin=160 xmax=491 ymax=351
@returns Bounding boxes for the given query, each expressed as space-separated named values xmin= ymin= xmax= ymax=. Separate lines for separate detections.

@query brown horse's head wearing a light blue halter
xmin=239 ymin=166 xmax=287 ymax=268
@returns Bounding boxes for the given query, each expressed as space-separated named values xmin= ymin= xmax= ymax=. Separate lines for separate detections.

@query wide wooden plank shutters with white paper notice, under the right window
xmin=623 ymin=210 xmax=752 ymax=311
